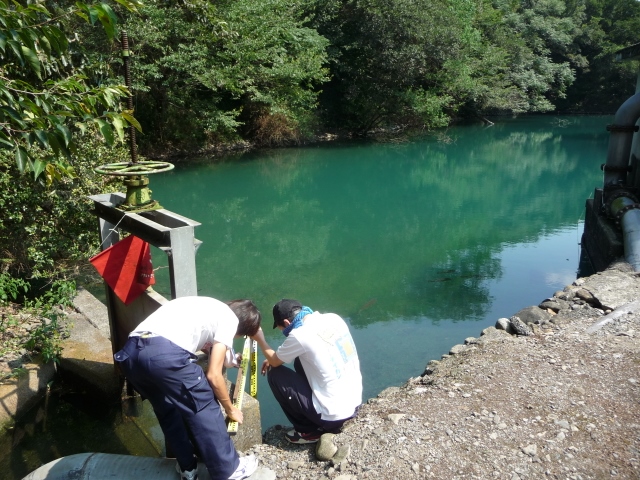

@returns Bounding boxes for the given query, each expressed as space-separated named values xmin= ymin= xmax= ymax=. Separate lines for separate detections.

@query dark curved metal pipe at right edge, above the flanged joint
xmin=603 ymin=92 xmax=640 ymax=188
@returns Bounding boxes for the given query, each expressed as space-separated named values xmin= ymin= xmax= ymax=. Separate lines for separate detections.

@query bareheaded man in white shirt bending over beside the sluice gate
xmin=114 ymin=297 xmax=261 ymax=480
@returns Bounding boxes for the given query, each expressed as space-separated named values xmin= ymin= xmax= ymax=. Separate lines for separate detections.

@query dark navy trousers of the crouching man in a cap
xmin=267 ymin=358 xmax=355 ymax=433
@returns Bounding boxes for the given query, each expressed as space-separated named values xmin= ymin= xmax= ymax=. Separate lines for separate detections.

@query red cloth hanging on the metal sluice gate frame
xmin=89 ymin=235 xmax=156 ymax=305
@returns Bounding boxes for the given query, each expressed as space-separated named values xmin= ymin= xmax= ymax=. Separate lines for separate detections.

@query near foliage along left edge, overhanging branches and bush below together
xmin=0 ymin=0 xmax=144 ymax=279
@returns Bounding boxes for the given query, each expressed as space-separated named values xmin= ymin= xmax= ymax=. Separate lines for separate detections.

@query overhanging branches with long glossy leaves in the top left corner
xmin=0 ymin=0 xmax=137 ymax=183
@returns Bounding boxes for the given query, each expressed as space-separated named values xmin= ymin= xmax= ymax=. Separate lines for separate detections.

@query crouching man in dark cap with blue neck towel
xmin=251 ymin=299 xmax=362 ymax=443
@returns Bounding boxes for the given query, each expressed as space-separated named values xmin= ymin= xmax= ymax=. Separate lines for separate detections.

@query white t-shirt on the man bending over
xmin=129 ymin=297 xmax=238 ymax=353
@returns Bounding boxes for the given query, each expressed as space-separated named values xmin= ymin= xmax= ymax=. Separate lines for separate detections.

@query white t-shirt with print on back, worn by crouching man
xmin=277 ymin=312 xmax=362 ymax=420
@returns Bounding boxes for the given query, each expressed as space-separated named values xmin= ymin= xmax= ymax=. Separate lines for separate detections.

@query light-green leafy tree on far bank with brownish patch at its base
xmin=121 ymin=0 xmax=327 ymax=149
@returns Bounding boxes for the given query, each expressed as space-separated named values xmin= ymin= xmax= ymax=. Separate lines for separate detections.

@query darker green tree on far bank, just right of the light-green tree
xmin=307 ymin=0 xmax=473 ymax=134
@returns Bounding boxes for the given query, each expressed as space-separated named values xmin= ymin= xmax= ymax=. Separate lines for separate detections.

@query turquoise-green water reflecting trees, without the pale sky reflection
xmin=151 ymin=115 xmax=606 ymax=325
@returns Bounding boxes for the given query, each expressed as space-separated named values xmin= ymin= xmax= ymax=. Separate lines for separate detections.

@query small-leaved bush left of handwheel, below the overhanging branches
xmin=0 ymin=134 xmax=128 ymax=279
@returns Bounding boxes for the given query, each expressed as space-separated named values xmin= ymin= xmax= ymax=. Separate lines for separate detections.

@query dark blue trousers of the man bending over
xmin=114 ymin=336 xmax=240 ymax=480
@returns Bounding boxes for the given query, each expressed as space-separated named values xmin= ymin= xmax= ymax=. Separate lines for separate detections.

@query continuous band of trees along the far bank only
xmin=116 ymin=0 xmax=640 ymax=148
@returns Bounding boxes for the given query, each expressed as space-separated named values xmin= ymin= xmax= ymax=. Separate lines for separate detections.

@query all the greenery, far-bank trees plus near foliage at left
xmin=0 ymin=0 xmax=640 ymax=286
